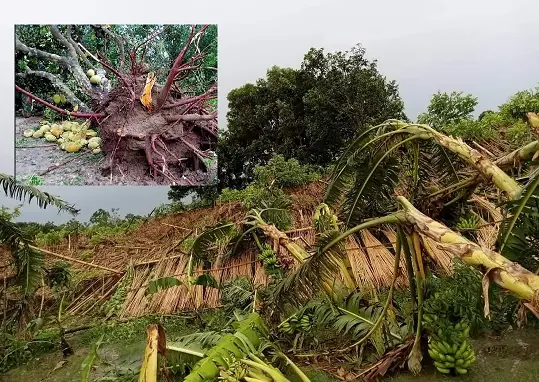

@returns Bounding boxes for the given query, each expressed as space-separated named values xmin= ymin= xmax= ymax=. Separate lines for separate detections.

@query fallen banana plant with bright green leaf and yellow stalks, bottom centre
xmin=139 ymin=313 xmax=309 ymax=382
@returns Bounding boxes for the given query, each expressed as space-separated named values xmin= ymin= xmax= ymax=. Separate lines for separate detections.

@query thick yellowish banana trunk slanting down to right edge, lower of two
xmin=395 ymin=196 xmax=539 ymax=308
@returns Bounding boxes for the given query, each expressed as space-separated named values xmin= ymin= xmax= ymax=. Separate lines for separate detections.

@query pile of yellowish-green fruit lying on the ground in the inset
xmin=23 ymin=121 xmax=101 ymax=154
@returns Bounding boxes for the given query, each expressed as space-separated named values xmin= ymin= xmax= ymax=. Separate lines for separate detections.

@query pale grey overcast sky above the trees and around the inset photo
xmin=0 ymin=0 xmax=539 ymax=222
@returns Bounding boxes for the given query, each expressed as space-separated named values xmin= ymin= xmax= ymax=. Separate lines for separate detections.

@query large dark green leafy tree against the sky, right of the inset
xmin=218 ymin=45 xmax=405 ymax=188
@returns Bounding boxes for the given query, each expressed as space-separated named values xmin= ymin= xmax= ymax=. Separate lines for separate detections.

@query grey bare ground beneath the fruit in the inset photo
xmin=15 ymin=117 xmax=217 ymax=186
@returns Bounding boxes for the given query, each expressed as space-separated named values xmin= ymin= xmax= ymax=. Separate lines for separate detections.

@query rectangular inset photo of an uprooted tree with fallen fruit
xmin=15 ymin=24 xmax=218 ymax=186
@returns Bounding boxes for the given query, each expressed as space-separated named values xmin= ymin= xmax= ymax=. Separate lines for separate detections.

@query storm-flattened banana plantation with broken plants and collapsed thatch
xmin=0 ymin=52 xmax=539 ymax=382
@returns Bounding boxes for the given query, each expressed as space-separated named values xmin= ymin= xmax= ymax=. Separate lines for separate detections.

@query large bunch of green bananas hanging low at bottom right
xmin=423 ymin=314 xmax=476 ymax=375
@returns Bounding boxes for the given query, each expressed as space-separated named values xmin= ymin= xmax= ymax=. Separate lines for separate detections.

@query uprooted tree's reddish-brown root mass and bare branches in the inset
xmin=15 ymin=25 xmax=217 ymax=185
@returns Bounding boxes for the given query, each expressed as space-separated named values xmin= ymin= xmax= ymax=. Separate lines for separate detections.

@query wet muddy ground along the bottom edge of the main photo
xmin=4 ymin=324 xmax=539 ymax=382
